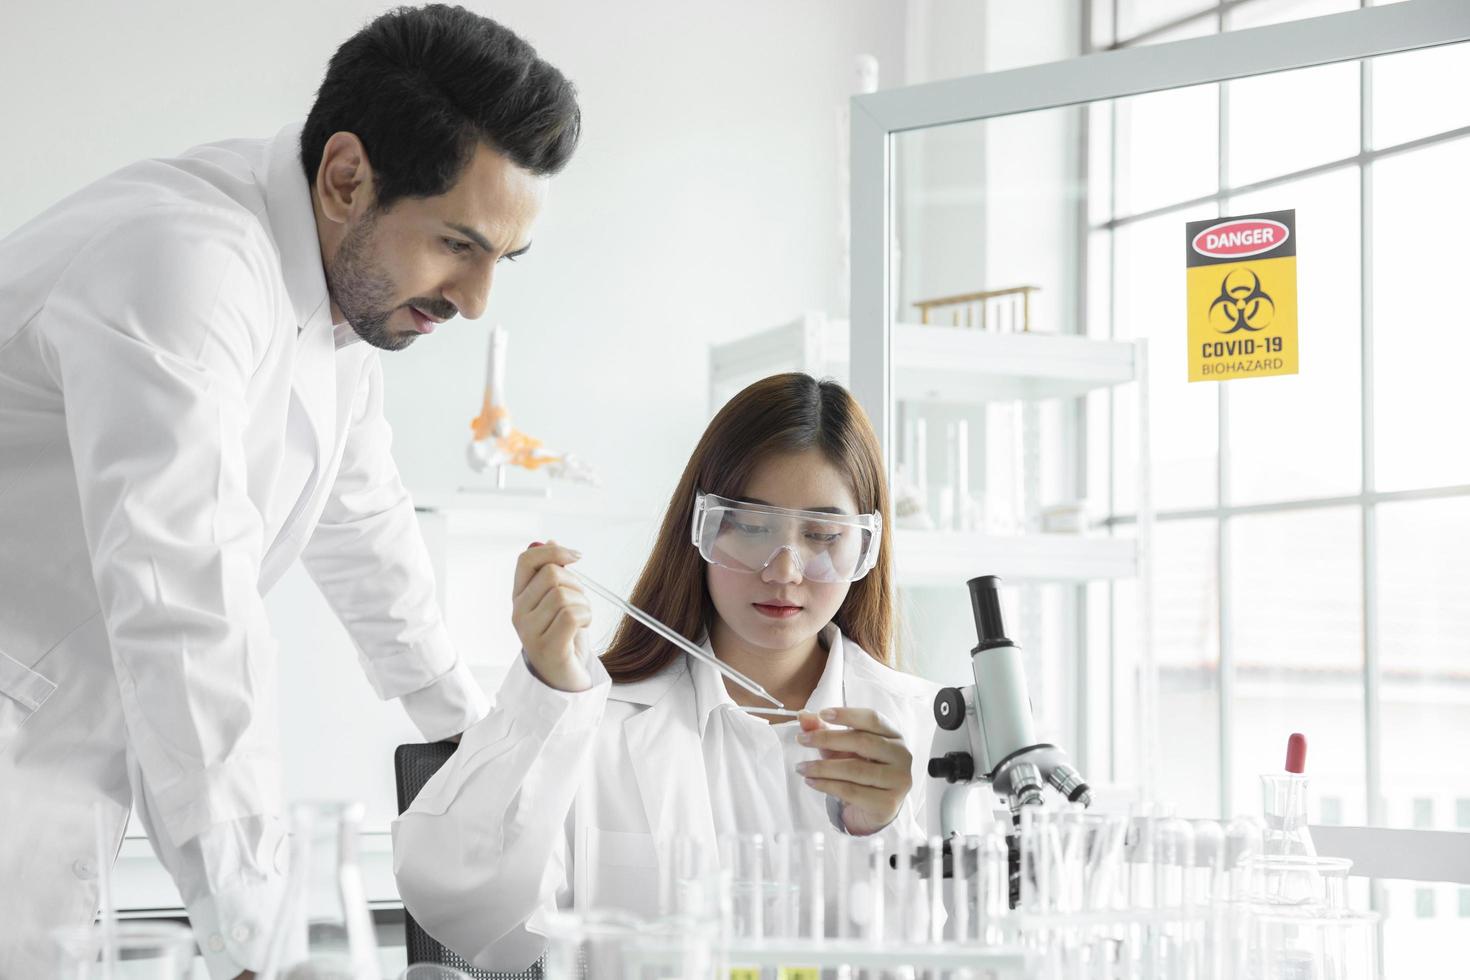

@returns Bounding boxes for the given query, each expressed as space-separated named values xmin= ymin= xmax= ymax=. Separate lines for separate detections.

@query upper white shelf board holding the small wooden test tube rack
xmin=710 ymin=313 xmax=1138 ymax=408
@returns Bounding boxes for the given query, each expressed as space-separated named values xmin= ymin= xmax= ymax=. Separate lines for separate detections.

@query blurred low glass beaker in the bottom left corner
xmin=51 ymin=921 xmax=194 ymax=980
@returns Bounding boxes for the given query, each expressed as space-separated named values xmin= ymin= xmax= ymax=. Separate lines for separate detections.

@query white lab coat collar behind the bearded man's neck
xmin=266 ymin=123 xmax=332 ymax=332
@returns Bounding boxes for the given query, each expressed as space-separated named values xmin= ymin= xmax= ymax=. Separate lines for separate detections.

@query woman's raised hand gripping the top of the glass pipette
xmin=510 ymin=541 xmax=592 ymax=691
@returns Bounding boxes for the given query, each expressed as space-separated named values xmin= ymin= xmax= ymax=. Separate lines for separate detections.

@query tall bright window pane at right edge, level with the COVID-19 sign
xmin=1373 ymin=140 xmax=1470 ymax=489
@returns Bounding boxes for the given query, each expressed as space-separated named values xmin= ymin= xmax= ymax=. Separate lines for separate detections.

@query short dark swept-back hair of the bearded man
xmin=301 ymin=3 xmax=582 ymax=207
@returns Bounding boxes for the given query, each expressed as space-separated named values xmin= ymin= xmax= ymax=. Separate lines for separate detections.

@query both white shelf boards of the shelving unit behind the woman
xmin=710 ymin=313 xmax=1147 ymax=588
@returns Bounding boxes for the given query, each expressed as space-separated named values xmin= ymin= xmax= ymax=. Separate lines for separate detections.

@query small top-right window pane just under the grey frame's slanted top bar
xmin=1372 ymin=44 xmax=1470 ymax=147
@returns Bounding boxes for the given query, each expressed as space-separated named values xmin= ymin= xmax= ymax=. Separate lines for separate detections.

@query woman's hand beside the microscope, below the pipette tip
xmin=797 ymin=708 xmax=914 ymax=836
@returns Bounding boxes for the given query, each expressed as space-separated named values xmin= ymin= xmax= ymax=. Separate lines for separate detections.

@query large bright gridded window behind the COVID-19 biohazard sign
xmin=1083 ymin=0 xmax=1470 ymax=976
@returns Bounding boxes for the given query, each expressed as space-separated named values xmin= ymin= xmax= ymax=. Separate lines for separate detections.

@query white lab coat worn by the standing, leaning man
xmin=0 ymin=126 xmax=487 ymax=979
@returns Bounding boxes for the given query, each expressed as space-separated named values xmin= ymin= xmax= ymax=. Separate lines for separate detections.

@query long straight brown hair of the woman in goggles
xmin=603 ymin=373 xmax=894 ymax=683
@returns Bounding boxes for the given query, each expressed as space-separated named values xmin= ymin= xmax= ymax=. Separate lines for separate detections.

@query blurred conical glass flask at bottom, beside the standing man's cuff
xmin=260 ymin=802 xmax=379 ymax=980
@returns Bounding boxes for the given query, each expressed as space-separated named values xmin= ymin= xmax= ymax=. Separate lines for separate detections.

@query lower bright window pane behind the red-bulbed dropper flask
xmin=1227 ymin=507 xmax=1367 ymax=824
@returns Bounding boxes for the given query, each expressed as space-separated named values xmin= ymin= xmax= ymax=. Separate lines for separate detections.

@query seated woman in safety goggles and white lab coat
xmin=394 ymin=373 xmax=936 ymax=968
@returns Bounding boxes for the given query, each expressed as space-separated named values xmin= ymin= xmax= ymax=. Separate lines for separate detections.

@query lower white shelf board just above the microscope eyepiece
xmin=894 ymin=527 xmax=1138 ymax=588
